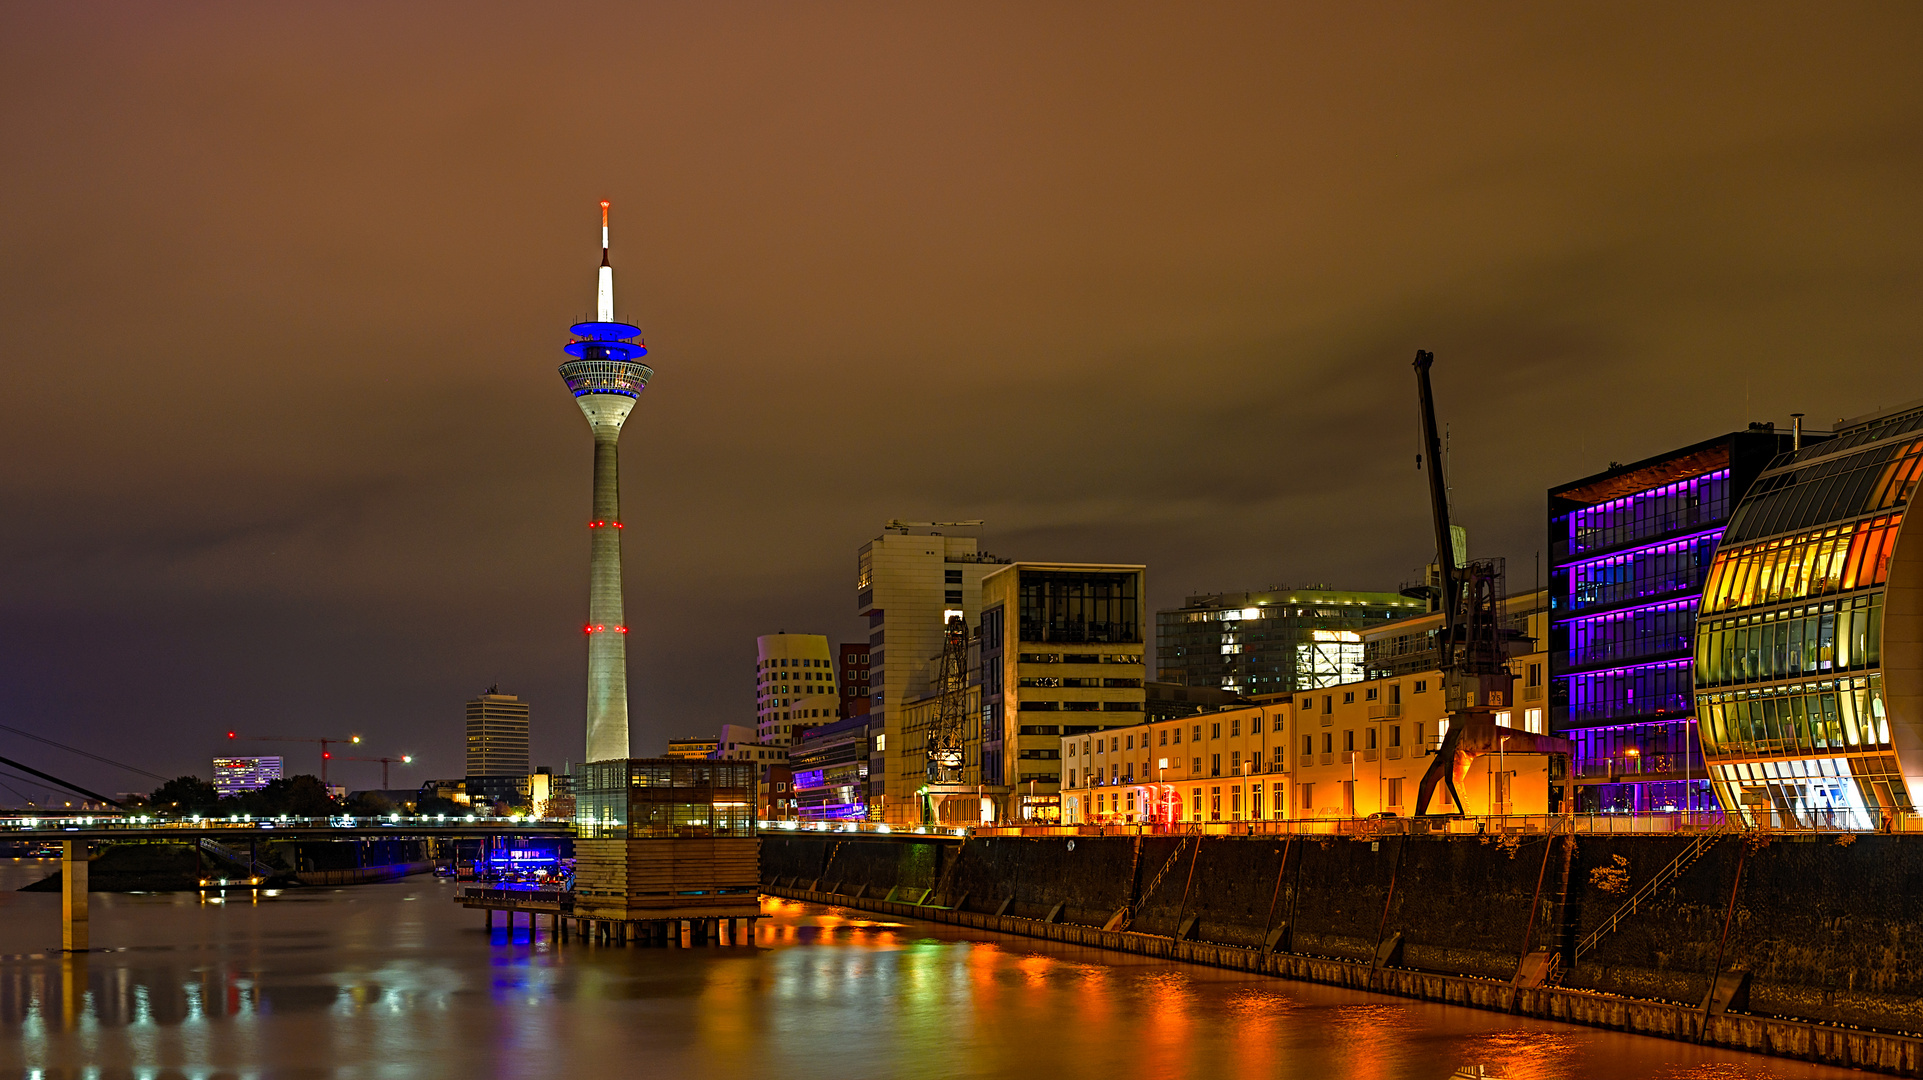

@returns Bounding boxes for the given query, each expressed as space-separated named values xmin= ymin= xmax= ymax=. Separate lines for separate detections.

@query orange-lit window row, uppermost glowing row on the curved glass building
xmin=1702 ymin=513 xmax=1904 ymax=615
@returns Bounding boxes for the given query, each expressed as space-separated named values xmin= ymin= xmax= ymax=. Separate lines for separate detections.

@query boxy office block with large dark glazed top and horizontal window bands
xmin=979 ymin=563 xmax=1148 ymax=824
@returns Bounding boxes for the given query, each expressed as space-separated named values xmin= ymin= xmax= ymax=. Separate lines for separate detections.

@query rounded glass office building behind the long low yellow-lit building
xmin=1156 ymin=586 xmax=1427 ymax=696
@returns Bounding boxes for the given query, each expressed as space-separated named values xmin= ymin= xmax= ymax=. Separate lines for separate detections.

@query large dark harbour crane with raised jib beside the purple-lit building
xmin=1415 ymin=350 xmax=1571 ymax=815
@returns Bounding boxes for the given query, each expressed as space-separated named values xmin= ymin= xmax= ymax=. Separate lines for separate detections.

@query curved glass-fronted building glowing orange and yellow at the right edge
xmin=1694 ymin=405 xmax=1923 ymax=828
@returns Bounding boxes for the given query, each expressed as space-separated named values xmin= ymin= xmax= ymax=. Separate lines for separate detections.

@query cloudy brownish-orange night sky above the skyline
xmin=0 ymin=2 xmax=1923 ymax=801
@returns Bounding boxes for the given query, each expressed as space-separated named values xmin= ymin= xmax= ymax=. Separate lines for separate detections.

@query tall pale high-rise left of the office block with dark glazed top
xmin=854 ymin=525 xmax=1008 ymax=822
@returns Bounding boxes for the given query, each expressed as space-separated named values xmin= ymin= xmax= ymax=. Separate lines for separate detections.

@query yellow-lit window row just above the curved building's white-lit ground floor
xmin=1696 ymin=675 xmax=1890 ymax=757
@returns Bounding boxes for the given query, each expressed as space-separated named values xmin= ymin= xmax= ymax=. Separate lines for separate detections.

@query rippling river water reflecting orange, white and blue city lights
xmin=0 ymin=861 xmax=1863 ymax=1080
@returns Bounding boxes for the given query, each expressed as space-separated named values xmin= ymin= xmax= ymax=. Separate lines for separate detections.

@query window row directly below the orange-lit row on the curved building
xmin=1696 ymin=594 xmax=1883 ymax=686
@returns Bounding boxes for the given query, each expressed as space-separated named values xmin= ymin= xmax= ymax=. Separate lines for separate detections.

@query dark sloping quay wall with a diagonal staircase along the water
xmin=762 ymin=834 xmax=1923 ymax=1076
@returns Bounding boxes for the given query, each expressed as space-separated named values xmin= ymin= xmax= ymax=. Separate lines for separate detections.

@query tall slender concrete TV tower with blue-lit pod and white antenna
xmin=562 ymin=202 xmax=654 ymax=761
